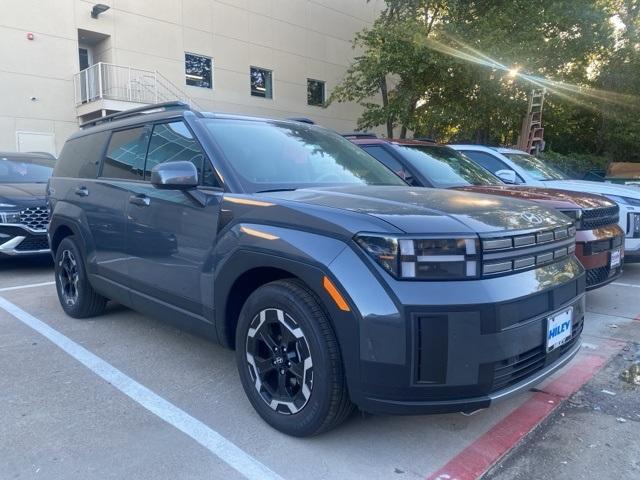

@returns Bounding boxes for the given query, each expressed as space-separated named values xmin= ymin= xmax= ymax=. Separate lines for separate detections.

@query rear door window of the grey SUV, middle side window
xmin=100 ymin=127 xmax=148 ymax=180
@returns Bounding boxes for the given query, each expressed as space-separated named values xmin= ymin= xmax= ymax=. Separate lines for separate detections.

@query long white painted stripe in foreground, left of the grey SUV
xmin=0 ymin=297 xmax=282 ymax=480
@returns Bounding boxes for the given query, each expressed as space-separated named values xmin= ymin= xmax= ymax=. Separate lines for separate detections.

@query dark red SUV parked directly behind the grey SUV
xmin=346 ymin=135 xmax=624 ymax=290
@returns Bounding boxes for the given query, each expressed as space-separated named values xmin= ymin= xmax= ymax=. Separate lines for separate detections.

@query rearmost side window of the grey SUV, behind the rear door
xmin=53 ymin=132 xmax=109 ymax=178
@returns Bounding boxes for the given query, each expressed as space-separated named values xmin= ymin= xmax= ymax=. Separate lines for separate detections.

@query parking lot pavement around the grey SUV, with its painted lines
xmin=0 ymin=260 xmax=640 ymax=479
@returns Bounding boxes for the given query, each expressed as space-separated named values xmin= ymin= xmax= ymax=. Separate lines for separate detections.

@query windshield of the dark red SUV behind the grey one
xmin=397 ymin=145 xmax=502 ymax=188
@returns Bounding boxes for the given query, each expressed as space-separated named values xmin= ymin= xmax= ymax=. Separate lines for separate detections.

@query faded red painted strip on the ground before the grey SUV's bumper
xmin=427 ymin=352 xmax=617 ymax=480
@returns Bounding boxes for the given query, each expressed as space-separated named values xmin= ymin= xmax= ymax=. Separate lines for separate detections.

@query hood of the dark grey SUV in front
xmin=259 ymin=186 xmax=569 ymax=233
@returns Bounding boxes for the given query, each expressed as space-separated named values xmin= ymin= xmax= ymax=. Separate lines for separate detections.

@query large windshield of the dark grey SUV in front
xmin=205 ymin=119 xmax=406 ymax=192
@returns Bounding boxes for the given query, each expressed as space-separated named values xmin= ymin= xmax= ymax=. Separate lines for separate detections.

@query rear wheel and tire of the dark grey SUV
xmin=54 ymin=236 xmax=107 ymax=318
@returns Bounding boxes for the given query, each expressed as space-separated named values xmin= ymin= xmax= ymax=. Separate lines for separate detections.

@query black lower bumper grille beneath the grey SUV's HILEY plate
xmin=491 ymin=319 xmax=584 ymax=392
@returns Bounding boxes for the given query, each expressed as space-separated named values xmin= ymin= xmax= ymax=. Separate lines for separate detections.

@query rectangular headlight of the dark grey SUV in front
xmin=355 ymin=234 xmax=480 ymax=280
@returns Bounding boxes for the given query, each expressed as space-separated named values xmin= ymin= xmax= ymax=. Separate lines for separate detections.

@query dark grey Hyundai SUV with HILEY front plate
xmin=49 ymin=104 xmax=585 ymax=436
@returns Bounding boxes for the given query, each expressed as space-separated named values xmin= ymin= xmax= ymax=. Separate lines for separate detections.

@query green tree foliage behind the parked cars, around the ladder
xmin=330 ymin=0 xmax=640 ymax=161
